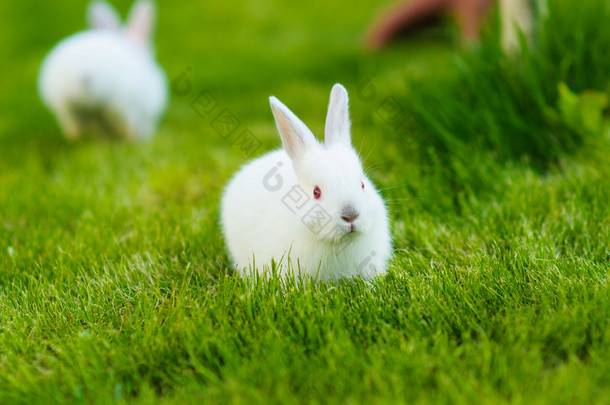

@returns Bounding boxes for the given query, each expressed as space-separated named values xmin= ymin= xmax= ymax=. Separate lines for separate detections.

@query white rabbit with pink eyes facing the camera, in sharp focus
xmin=221 ymin=84 xmax=392 ymax=280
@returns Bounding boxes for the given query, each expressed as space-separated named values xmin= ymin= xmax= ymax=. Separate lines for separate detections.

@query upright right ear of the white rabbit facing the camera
xmin=324 ymin=83 xmax=351 ymax=145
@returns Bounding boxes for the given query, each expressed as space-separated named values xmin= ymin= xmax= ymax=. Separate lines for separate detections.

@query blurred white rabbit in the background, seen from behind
xmin=38 ymin=0 xmax=168 ymax=139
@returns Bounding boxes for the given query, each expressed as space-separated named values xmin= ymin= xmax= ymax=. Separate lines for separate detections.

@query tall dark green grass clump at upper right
xmin=395 ymin=0 xmax=610 ymax=196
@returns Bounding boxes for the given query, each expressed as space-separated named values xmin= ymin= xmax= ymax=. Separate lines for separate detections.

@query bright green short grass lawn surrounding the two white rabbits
xmin=0 ymin=0 xmax=610 ymax=404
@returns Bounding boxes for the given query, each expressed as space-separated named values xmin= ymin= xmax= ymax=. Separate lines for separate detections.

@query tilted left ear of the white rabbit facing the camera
xmin=269 ymin=96 xmax=318 ymax=161
